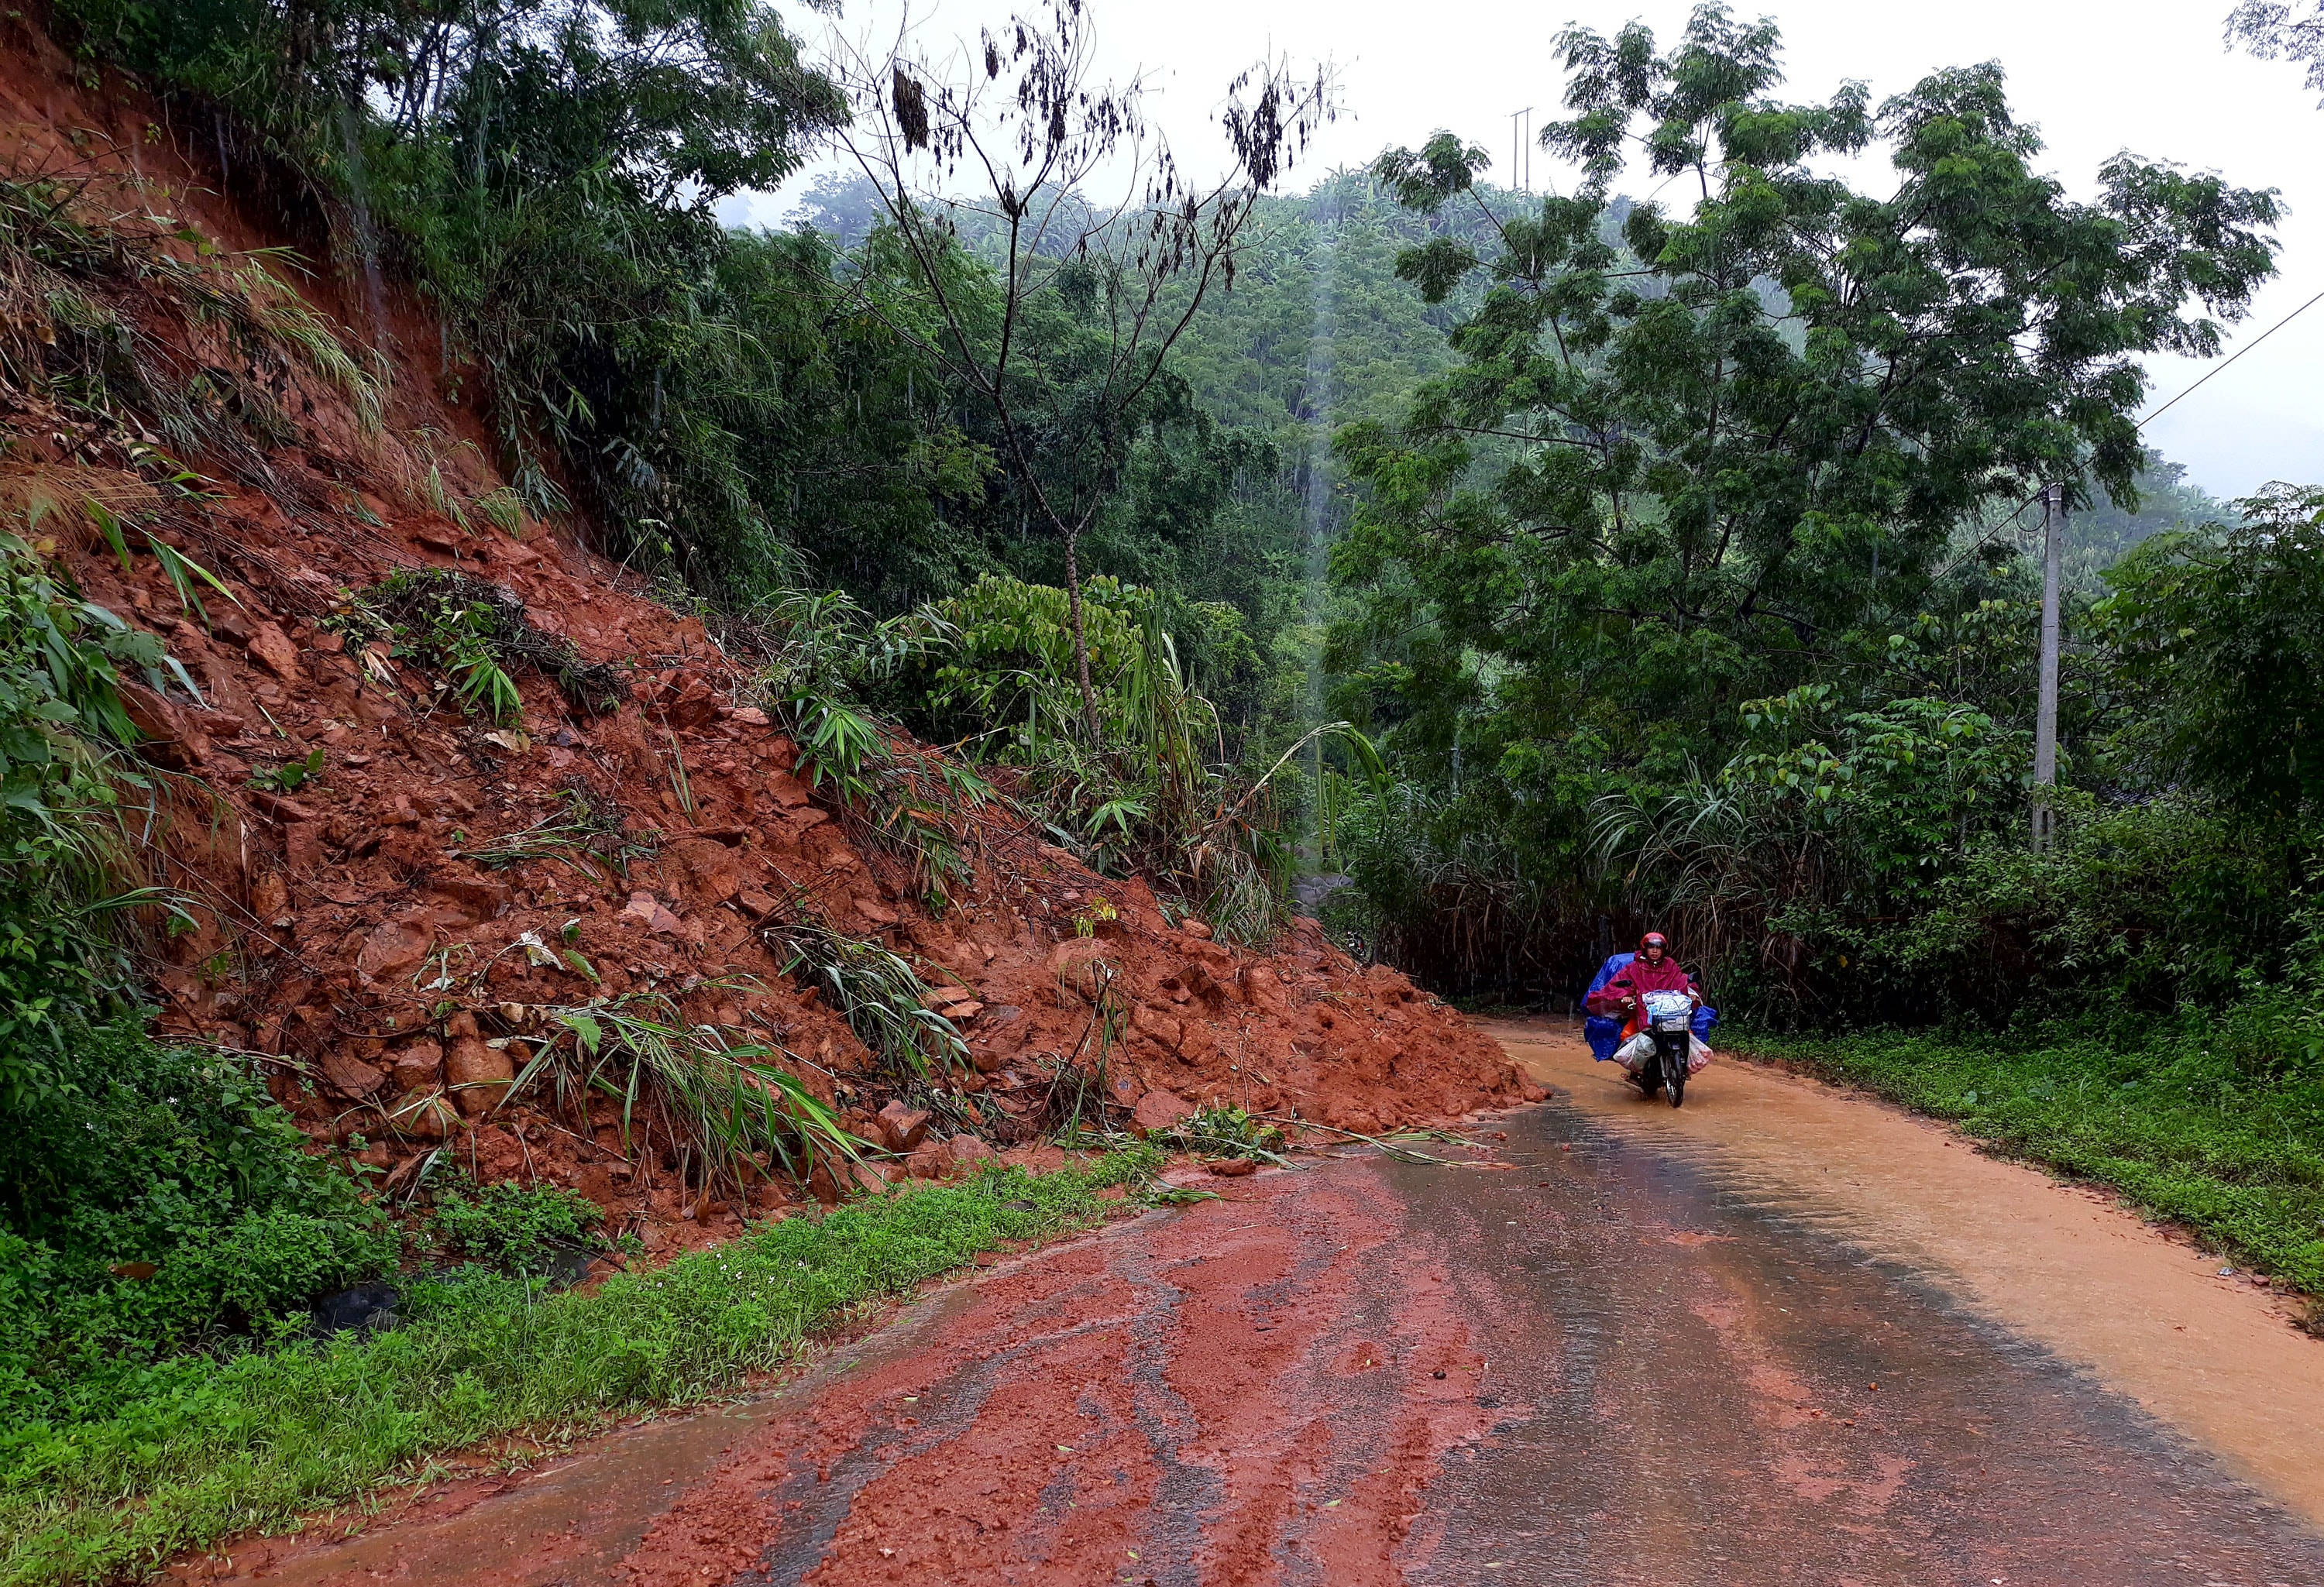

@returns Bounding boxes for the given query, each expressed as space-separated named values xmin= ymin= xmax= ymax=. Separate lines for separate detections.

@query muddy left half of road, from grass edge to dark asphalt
xmin=209 ymin=1164 xmax=1499 ymax=1587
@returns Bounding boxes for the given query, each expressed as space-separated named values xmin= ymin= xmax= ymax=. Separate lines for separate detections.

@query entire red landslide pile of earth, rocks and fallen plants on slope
xmin=0 ymin=40 xmax=1525 ymax=1248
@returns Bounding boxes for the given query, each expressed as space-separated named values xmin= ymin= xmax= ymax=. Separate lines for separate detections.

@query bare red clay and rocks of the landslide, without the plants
xmin=0 ymin=19 xmax=1538 ymax=1248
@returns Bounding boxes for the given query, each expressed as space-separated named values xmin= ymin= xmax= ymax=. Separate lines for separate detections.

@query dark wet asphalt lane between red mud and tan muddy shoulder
xmin=1378 ymin=1104 xmax=2324 ymax=1587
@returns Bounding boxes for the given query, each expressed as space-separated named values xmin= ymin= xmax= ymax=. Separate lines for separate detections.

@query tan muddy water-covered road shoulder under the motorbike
xmin=1478 ymin=1020 xmax=2324 ymax=1527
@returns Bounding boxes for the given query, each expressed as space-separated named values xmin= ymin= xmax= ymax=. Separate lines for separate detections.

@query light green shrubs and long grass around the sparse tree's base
xmin=758 ymin=576 xmax=1383 ymax=941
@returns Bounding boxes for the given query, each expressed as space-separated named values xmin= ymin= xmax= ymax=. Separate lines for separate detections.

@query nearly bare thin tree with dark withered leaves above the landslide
xmin=841 ymin=0 xmax=1334 ymax=739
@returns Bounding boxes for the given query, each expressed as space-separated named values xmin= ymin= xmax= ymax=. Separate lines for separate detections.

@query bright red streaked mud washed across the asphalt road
xmin=623 ymin=1164 xmax=1485 ymax=1587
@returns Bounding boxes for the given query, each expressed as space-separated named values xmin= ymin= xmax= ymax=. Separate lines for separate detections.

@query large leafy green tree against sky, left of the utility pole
xmin=1334 ymin=7 xmax=2278 ymax=985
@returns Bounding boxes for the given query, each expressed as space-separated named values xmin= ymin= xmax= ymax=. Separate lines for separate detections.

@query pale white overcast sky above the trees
xmin=727 ymin=0 xmax=2324 ymax=497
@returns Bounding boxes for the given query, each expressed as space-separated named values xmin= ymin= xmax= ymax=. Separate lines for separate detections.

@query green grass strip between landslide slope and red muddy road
xmin=0 ymin=1152 xmax=1150 ymax=1587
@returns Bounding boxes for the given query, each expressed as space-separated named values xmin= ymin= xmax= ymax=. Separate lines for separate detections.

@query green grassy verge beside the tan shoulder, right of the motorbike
xmin=1731 ymin=1032 xmax=2324 ymax=1297
